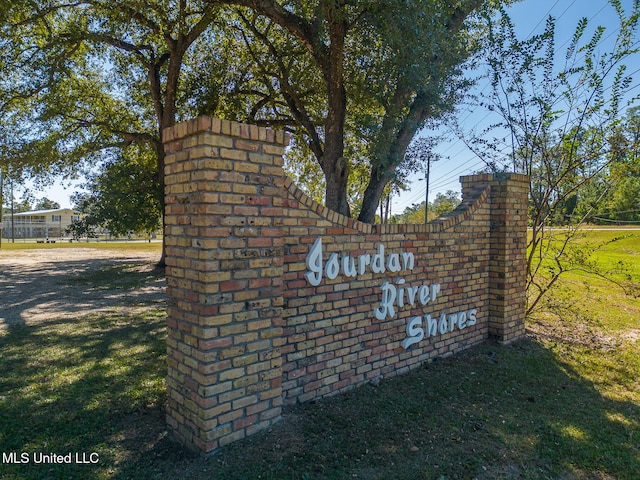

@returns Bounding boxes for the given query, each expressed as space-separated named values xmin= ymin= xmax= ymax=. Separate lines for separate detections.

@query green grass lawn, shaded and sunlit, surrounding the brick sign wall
xmin=0 ymin=232 xmax=640 ymax=480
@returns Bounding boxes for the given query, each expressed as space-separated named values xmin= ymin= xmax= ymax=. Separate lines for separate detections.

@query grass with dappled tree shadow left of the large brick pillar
xmin=0 ymin=310 xmax=181 ymax=479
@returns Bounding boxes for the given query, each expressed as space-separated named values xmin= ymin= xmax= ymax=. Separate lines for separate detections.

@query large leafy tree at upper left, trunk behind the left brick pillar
xmin=0 ymin=0 xmax=228 ymax=262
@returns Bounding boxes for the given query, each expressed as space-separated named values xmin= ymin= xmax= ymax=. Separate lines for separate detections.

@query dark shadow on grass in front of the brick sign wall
xmin=100 ymin=340 xmax=640 ymax=480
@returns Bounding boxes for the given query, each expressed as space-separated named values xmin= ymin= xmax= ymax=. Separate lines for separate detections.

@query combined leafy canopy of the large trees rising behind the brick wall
xmin=0 ymin=0 xmax=497 ymax=234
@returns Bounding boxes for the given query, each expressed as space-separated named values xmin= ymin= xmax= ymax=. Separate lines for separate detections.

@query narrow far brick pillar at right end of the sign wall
xmin=489 ymin=174 xmax=529 ymax=344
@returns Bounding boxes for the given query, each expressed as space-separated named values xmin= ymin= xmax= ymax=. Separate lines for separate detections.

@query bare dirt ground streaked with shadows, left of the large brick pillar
xmin=0 ymin=248 xmax=165 ymax=330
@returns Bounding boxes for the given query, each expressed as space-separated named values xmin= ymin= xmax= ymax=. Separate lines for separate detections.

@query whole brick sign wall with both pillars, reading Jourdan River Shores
xmin=163 ymin=117 xmax=529 ymax=453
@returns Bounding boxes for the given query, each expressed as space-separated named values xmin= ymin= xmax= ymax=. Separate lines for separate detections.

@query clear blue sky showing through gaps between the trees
xmin=33 ymin=0 xmax=640 ymax=214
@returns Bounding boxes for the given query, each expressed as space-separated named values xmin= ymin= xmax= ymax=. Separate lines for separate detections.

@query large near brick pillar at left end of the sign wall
xmin=163 ymin=117 xmax=287 ymax=453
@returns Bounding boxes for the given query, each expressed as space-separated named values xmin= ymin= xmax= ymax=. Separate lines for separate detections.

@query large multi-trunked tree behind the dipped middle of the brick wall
xmin=212 ymin=0 xmax=489 ymax=223
